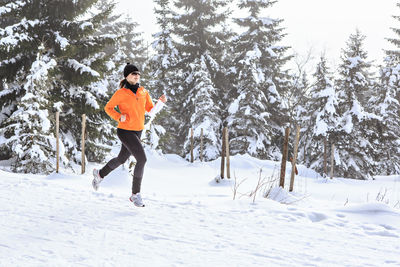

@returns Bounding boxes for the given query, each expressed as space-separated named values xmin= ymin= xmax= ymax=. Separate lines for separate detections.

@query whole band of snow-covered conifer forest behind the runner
xmin=0 ymin=0 xmax=400 ymax=179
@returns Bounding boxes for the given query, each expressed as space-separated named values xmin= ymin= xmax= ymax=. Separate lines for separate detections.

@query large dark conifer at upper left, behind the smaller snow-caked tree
xmin=0 ymin=0 xmax=115 ymax=172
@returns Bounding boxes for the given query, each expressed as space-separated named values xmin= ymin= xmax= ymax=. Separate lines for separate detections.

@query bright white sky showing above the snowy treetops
xmin=116 ymin=0 xmax=400 ymax=70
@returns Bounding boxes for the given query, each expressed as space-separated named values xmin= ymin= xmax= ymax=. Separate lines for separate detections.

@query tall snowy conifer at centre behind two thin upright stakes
xmin=171 ymin=0 xmax=229 ymax=160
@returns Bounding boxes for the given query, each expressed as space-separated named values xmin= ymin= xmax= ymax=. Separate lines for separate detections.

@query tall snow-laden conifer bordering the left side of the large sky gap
xmin=228 ymin=0 xmax=290 ymax=159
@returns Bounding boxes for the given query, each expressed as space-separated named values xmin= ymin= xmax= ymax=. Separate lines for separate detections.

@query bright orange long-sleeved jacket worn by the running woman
xmin=104 ymin=87 xmax=154 ymax=131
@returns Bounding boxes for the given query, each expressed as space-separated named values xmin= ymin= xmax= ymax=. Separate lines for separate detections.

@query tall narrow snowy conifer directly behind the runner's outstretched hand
xmin=148 ymin=0 xmax=180 ymax=154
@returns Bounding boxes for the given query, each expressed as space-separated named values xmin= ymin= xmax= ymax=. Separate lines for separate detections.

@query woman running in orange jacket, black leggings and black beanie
xmin=92 ymin=63 xmax=167 ymax=207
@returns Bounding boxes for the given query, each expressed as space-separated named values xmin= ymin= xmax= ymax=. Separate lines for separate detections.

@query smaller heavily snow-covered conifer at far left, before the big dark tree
xmin=1 ymin=47 xmax=57 ymax=173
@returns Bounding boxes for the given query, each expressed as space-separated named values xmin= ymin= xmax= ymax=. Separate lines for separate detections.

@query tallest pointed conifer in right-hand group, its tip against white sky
xmin=331 ymin=30 xmax=379 ymax=179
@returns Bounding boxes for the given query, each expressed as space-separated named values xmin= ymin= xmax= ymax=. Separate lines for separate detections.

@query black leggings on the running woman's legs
xmin=100 ymin=128 xmax=147 ymax=194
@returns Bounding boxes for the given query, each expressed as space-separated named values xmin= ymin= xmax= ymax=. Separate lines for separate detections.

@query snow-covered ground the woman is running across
xmin=0 ymin=151 xmax=400 ymax=266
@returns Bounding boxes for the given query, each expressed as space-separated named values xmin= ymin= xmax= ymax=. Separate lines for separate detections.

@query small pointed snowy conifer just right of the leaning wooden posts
xmin=303 ymin=56 xmax=339 ymax=174
